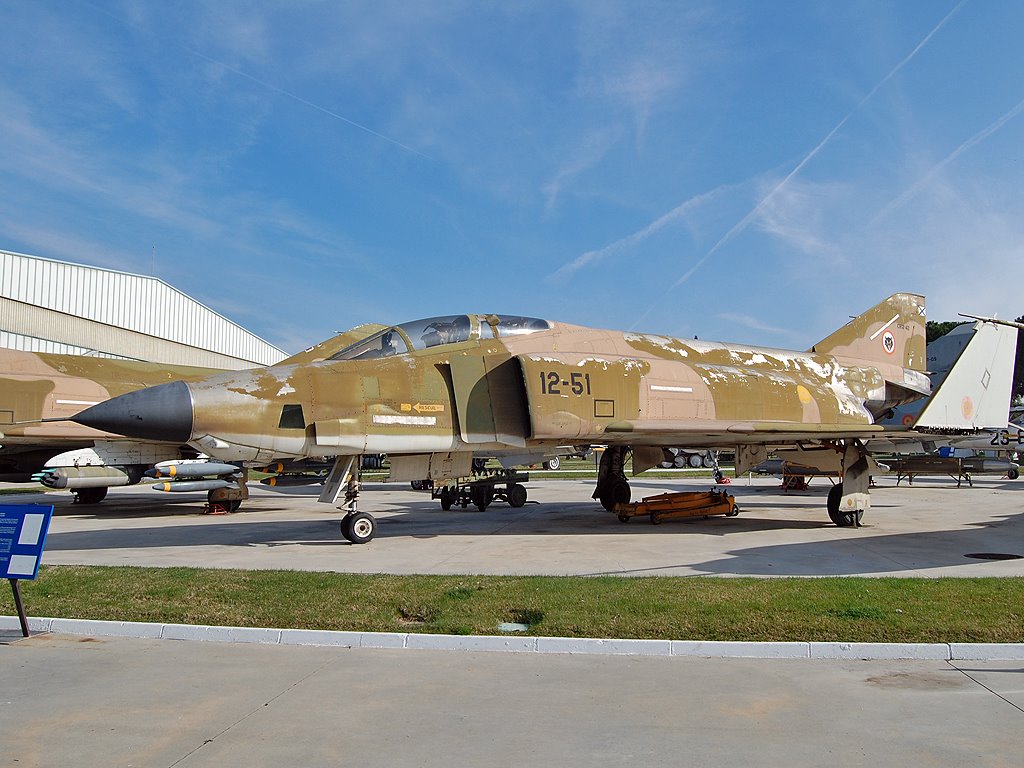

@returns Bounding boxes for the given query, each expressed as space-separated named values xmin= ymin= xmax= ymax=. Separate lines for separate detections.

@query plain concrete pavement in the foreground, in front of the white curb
xmin=0 ymin=635 xmax=1024 ymax=768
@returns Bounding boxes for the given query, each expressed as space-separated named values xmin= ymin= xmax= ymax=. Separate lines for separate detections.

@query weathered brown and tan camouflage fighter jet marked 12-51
xmin=75 ymin=294 xmax=1016 ymax=543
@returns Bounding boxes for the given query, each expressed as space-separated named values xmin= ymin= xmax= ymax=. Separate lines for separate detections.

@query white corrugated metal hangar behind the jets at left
xmin=0 ymin=250 xmax=286 ymax=369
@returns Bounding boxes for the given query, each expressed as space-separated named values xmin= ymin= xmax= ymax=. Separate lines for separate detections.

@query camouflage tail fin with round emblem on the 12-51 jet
xmin=810 ymin=293 xmax=927 ymax=372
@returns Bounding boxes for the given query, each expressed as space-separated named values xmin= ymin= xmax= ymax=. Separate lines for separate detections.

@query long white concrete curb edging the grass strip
xmin=0 ymin=615 xmax=1024 ymax=662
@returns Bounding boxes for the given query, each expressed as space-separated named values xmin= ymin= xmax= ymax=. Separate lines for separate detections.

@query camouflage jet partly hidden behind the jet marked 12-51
xmin=0 ymin=325 xmax=384 ymax=504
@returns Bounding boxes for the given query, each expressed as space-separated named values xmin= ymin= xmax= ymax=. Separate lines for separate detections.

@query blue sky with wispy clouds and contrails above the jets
xmin=0 ymin=0 xmax=1024 ymax=351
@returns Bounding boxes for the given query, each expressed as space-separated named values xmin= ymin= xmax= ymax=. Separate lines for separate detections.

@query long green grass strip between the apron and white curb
xmin=0 ymin=566 xmax=1024 ymax=642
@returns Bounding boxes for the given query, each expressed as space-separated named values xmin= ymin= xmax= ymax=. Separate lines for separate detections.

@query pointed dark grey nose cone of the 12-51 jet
xmin=72 ymin=381 xmax=193 ymax=442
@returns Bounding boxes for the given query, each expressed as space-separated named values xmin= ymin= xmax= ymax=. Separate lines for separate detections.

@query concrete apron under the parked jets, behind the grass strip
xmin=14 ymin=477 xmax=1024 ymax=578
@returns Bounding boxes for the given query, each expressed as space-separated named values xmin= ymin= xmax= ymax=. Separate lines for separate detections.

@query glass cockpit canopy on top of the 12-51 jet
xmin=330 ymin=314 xmax=551 ymax=360
